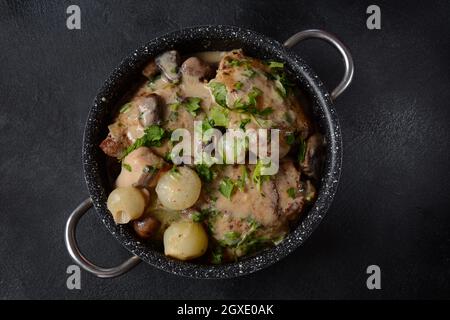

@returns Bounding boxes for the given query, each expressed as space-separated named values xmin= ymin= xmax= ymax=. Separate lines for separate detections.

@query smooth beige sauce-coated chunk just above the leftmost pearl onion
xmin=116 ymin=147 xmax=166 ymax=188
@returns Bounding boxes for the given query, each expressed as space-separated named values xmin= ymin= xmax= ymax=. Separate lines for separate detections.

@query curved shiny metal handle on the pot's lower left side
xmin=64 ymin=198 xmax=141 ymax=278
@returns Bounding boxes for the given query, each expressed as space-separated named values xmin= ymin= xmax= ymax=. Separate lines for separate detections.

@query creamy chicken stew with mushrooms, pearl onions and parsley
xmin=100 ymin=49 xmax=324 ymax=263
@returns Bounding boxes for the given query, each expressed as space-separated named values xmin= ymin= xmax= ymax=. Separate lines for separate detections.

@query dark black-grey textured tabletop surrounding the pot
xmin=0 ymin=0 xmax=450 ymax=299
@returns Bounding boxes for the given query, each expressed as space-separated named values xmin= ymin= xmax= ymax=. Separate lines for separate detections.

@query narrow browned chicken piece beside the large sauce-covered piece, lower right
xmin=275 ymin=159 xmax=304 ymax=220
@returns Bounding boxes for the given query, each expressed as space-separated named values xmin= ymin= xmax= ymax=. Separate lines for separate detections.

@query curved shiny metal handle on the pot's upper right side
xmin=284 ymin=29 xmax=355 ymax=100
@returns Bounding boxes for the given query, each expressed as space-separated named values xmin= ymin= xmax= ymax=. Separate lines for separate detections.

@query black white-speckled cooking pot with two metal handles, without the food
xmin=65 ymin=26 xmax=353 ymax=278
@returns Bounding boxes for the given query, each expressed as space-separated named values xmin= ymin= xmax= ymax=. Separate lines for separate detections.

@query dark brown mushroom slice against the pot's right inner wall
xmin=300 ymin=133 xmax=323 ymax=179
